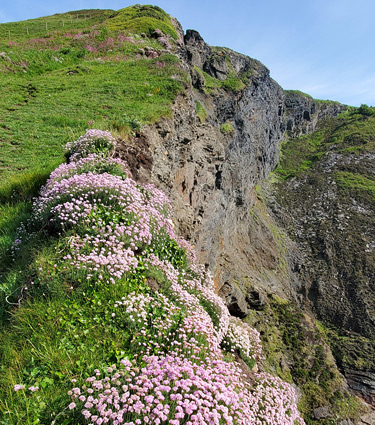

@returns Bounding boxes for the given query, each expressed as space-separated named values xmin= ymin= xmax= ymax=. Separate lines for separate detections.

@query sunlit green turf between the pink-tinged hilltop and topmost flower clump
xmin=0 ymin=55 xmax=183 ymax=176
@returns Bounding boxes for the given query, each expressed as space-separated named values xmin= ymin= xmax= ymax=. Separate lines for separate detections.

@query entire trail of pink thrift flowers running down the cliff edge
xmin=19 ymin=130 xmax=304 ymax=425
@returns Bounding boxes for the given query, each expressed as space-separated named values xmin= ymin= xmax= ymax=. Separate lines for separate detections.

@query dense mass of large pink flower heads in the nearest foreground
xmin=69 ymin=353 xmax=304 ymax=425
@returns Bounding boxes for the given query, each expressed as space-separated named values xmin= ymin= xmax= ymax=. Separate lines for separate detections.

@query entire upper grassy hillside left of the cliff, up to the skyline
xmin=0 ymin=4 xmax=186 ymax=304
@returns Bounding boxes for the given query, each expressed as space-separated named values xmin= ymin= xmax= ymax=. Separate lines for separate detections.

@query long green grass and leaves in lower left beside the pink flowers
xmin=0 ymin=146 xmax=192 ymax=425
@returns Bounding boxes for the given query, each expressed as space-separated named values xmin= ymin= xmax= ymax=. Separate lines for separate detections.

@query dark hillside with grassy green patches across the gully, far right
xmin=274 ymin=107 xmax=375 ymax=405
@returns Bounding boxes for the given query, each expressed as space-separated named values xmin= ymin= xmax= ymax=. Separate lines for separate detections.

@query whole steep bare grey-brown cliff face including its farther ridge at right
xmin=118 ymin=20 xmax=372 ymax=423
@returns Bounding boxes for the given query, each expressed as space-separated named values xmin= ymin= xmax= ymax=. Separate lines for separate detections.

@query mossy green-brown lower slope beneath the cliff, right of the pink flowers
xmin=246 ymin=296 xmax=362 ymax=425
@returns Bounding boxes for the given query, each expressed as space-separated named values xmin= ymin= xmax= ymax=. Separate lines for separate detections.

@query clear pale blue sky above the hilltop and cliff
xmin=0 ymin=0 xmax=375 ymax=106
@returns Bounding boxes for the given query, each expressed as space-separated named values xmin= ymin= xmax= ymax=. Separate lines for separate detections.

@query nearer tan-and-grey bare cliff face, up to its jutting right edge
xmin=140 ymin=31 xmax=290 ymax=304
